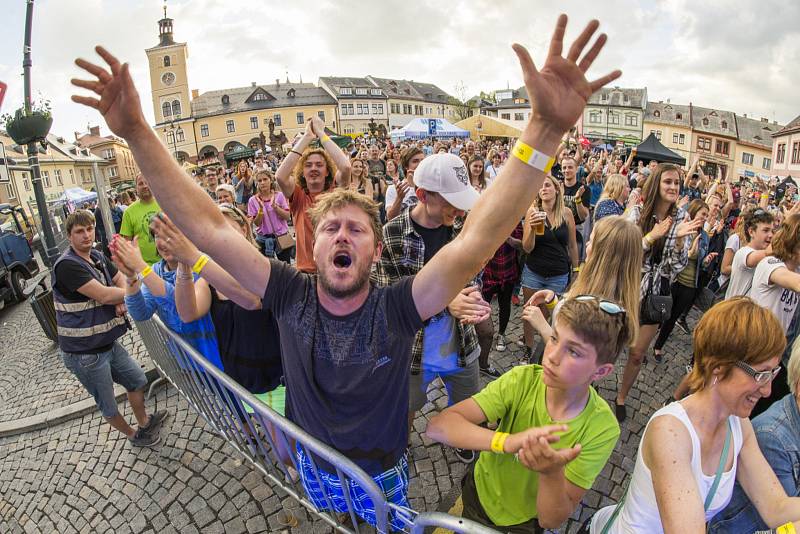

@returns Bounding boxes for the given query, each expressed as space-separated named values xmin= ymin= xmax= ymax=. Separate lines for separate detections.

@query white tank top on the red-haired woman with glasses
xmin=590 ymin=402 xmax=742 ymax=534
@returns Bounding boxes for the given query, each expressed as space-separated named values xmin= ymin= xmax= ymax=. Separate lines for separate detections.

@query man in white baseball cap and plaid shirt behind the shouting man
xmin=375 ymin=154 xmax=500 ymax=463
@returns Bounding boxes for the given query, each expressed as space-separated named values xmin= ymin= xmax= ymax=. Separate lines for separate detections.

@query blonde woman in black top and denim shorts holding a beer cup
xmin=522 ymin=176 xmax=578 ymax=359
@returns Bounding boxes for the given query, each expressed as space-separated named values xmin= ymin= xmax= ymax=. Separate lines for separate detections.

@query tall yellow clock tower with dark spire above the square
xmin=145 ymin=5 xmax=197 ymax=160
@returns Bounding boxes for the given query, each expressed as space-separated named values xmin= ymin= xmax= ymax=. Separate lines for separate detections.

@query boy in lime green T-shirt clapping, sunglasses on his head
xmin=426 ymin=295 xmax=633 ymax=533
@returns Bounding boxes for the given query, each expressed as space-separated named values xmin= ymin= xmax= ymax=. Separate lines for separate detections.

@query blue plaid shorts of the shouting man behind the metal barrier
xmin=297 ymin=446 xmax=410 ymax=530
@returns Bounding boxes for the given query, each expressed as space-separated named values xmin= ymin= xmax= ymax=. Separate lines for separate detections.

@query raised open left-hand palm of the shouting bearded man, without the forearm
xmin=71 ymin=46 xmax=150 ymax=138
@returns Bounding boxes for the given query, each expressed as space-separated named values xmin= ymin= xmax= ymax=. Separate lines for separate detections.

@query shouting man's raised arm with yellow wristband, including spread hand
xmin=412 ymin=15 xmax=622 ymax=319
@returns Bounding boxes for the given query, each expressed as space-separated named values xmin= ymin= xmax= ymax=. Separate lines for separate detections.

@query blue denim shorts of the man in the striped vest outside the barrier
xmin=59 ymin=341 xmax=147 ymax=417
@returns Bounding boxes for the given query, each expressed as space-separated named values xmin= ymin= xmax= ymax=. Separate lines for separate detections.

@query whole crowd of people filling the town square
xmin=53 ymin=16 xmax=800 ymax=534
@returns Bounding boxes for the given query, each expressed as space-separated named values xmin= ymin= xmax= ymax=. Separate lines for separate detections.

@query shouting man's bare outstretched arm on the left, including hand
xmin=72 ymin=46 xmax=269 ymax=295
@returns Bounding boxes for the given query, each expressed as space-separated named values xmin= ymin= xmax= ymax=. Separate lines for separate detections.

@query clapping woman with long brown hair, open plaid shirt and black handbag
xmin=614 ymin=163 xmax=703 ymax=422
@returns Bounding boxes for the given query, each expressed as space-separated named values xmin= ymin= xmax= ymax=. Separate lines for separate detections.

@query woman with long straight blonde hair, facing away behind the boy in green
xmin=522 ymin=216 xmax=642 ymax=354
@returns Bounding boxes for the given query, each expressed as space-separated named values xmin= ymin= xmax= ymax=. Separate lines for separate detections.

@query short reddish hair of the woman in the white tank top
xmin=689 ymin=297 xmax=786 ymax=391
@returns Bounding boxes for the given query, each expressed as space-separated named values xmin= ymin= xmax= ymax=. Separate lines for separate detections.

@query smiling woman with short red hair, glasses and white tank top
xmin=590 ymin=297 xmax=800 ymax=534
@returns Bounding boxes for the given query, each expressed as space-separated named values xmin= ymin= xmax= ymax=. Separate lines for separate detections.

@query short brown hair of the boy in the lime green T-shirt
xmin=556 ymin=297 xmax=633 ymax=365
